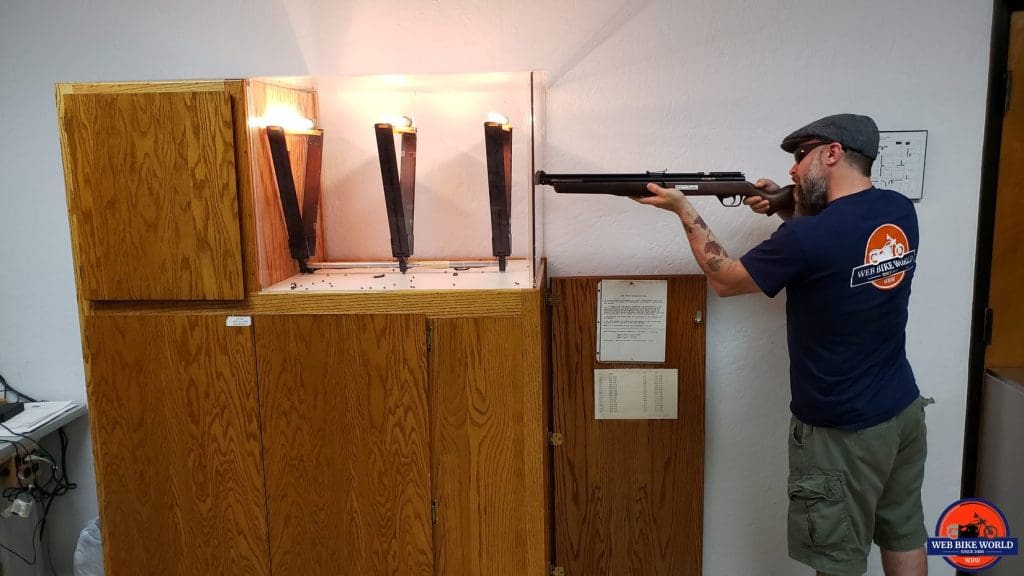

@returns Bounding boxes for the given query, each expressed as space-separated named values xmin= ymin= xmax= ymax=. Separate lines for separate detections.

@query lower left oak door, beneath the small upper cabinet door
xmin=85 ymin=316 xmax=269 ymax=576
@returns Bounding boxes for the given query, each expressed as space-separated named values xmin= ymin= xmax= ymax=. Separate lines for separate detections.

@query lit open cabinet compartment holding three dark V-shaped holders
xmin=246 ymin=72 xmax=545 ymax=293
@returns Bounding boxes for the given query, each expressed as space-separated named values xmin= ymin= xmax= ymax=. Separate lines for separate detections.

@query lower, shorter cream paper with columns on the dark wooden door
xmin=594 ymin=368 xmax=679 ymax=420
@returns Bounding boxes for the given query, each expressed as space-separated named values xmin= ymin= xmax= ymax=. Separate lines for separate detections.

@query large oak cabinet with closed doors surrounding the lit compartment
xmin=57 ymin=81 xmax=551 ymax=576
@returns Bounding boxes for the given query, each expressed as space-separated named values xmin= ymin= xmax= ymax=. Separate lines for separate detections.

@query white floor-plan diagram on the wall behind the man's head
xmin=871 ymin=130 xmax=928 ymax=200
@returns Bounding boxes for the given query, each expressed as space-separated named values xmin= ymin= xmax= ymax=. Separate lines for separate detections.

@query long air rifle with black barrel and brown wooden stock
xmin=537 ymin=170 xmax=794 ymax=215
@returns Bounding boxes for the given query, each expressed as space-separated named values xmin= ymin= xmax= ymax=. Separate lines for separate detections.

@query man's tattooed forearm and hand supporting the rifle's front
xmin=633 ymin=183 xmax=760 ymax=296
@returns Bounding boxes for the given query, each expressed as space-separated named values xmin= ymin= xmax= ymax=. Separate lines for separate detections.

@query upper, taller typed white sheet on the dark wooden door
xmin=597 ymin=280 xmax=669 ymax=362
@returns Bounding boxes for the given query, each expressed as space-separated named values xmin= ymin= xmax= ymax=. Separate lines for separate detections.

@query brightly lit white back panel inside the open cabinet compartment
xmin=316 ymin=73 xmax=532 ymax=260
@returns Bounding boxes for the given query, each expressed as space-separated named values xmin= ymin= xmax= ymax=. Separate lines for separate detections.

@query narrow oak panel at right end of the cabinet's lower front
xmin=430 ymin=318 xmax=540 ymax=576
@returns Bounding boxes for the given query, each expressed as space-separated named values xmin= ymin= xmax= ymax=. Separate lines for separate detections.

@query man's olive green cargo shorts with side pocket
xmin=787 ymin=397 xmax=935 ymax=576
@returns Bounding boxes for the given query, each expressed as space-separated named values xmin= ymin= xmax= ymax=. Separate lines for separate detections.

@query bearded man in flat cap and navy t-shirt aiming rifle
xmin=636 ymin=114 xmax=931 ymax=576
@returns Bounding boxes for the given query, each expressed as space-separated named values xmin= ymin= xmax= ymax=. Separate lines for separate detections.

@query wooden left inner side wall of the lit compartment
xmin=247 ymin=80 xmax=319 ymax=288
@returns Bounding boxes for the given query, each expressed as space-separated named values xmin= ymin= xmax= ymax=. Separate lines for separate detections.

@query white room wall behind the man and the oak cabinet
xmin=0 ymin=0 xmax=991 ymax=575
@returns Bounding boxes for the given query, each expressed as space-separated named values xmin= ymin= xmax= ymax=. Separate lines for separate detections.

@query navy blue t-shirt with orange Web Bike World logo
xmin=740 ymin=188 xmax=919 ymax=429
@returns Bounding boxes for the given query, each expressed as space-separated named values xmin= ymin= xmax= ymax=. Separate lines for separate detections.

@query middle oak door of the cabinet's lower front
xmin=255 ymin=315 xmax=433 ymax=576
